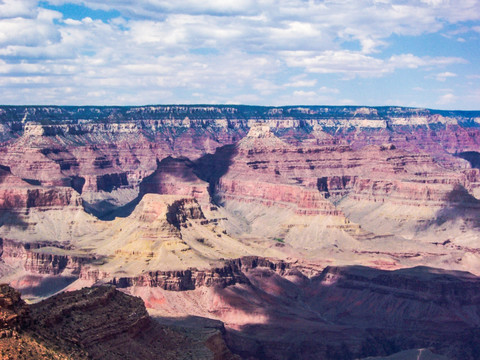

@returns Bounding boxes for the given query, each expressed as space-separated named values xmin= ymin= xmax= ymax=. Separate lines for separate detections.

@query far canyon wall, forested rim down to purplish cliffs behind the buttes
xmin=0 ymin=106 xmax=480 ymax=172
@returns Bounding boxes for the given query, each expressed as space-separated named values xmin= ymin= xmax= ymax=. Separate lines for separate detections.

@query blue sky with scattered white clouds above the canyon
xmin=0 ymin=0 xmax=480 ymax=110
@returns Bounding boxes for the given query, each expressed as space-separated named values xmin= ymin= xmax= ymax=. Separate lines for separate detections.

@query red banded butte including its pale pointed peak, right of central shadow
xmin=208 ymin=127 xmax=467 ymax=208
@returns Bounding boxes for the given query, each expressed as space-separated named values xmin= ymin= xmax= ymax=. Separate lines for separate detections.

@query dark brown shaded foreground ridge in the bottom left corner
xmin=0 ymin=285 xmax=237 ymax=360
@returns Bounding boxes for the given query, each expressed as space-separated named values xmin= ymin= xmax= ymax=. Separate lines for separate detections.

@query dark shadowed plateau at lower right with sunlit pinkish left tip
xmin=89 ymin=257 xmax=480 ymax=359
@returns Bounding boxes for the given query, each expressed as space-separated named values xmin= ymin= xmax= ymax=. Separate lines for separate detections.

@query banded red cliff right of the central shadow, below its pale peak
xmin=213 ymin=134 xmax=464 ymax=215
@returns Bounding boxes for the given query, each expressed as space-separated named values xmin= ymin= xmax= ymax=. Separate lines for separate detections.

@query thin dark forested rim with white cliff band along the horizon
xmin=0 ymin=105 xmax=480 ymax=131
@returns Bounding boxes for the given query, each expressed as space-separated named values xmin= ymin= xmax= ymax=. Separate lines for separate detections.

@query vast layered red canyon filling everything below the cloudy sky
xmin=0 ymin=105 xmax=480 ymax=359
